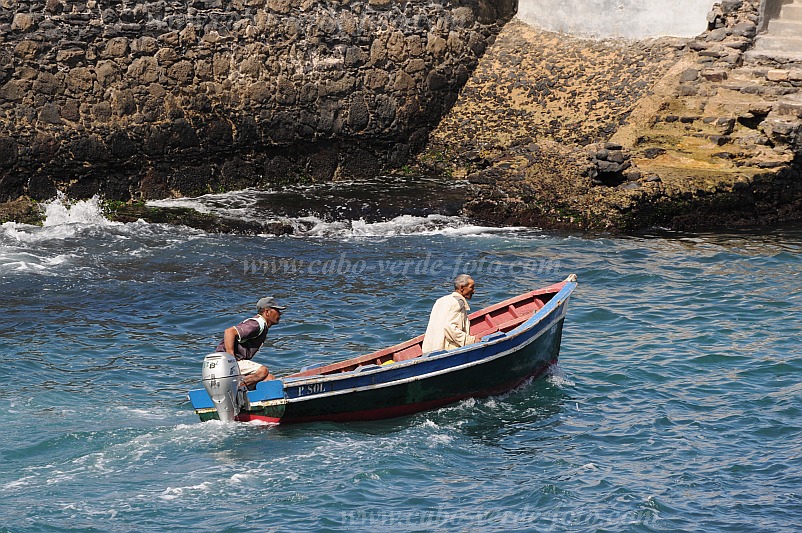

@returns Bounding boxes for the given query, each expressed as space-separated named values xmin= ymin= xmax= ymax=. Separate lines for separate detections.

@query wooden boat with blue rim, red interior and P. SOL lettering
xmin=189 ymin=275 xmax=577 ymax=424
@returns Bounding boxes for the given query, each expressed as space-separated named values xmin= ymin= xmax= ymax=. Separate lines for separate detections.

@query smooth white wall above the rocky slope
xmin=518 ymin=0 xmax=715 ymax=39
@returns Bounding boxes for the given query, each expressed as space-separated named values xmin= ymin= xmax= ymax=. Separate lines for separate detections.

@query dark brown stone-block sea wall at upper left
xmin=0 ymin=0 xmax=515 ymax=201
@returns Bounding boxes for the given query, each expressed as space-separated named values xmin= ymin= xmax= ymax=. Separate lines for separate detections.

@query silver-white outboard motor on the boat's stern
xmin=203 ymin=352 xmax=250 ymax=422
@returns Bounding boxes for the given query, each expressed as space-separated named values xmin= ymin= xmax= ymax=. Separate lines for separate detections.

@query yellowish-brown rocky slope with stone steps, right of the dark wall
xmin=419 ymin=0 xmax=802 ymax=232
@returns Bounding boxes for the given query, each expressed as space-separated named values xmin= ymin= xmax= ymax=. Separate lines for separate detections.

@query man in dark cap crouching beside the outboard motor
xmin=215 ymin=296 xmax=286 ymax=389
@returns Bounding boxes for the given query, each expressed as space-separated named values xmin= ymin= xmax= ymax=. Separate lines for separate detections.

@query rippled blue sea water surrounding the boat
xmin=0 ymin=189 xmax=802 ymax=532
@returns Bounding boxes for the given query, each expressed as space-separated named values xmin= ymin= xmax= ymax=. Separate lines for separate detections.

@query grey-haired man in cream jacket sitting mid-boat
xmin=423 ymin=274 xmax=476 ymax=353
